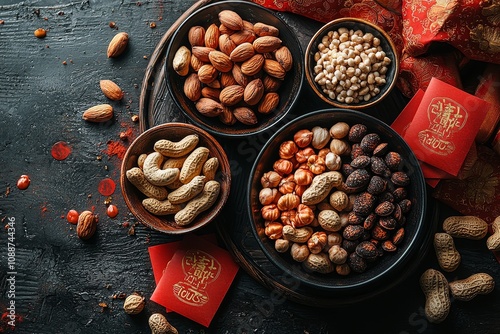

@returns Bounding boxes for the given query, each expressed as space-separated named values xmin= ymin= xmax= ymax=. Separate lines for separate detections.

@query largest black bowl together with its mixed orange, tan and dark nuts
xmin=247 ymin=109 xmax=431 ymax=295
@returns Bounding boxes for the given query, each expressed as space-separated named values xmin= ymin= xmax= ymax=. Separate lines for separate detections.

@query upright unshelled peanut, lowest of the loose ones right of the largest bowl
xmin=420 ymin=269 xmax=451 ymax=323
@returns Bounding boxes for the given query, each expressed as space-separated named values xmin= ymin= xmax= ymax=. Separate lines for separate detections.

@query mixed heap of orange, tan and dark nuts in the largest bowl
xmin=259 ymin=122 xmax=412 ymax=275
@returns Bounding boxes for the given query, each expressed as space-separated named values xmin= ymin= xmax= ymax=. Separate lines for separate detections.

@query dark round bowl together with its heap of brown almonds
xmin=165 ymin=1 xmax=304 ymax=137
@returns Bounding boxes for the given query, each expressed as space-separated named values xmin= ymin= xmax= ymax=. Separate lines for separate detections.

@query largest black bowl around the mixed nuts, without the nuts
xmin=247 ymin=109 xmax=431 ymax=298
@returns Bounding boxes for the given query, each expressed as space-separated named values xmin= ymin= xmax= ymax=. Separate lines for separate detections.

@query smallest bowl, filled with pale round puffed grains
xmin=305 ymin=18 xmax=399 ymax=109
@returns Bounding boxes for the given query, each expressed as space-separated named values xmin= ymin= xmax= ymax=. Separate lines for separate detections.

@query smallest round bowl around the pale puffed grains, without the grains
xmin=305 ymin=17 xmax=399 ymax=109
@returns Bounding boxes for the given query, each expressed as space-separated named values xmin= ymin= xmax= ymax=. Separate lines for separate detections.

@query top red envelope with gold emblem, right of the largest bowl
xmin=404 ymin=78 xmax=489 ymax=176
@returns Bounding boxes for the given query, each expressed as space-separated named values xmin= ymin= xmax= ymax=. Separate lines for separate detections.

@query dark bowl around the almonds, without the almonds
xmin=165 ymin=1 xmax=304 ymax=137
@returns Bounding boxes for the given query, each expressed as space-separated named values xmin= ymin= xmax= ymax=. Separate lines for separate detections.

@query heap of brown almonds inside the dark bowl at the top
xmin=172 ymin=10 xmax=293 ymax=125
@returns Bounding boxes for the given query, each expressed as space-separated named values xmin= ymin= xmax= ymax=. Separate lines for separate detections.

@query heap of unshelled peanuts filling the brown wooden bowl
xmin=126 ymin=134 xmax=220 ymax=226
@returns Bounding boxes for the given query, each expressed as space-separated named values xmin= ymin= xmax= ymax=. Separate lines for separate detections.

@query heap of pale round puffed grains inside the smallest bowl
xmin=314 ymin=27 xmax=391 ymax=104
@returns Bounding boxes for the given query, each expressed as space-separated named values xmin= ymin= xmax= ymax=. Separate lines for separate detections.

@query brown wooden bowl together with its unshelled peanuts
xmin=120 ymin=123 xmax=231 ymax=234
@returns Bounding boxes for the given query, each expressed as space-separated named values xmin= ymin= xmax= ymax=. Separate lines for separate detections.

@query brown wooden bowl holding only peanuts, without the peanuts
xmin=120 ymin=123 xmax=231 ymax=234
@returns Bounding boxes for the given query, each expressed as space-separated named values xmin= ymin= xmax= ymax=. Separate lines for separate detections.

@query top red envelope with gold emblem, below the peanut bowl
xmin=151 ymin=235 xmax=238 ymax=327
